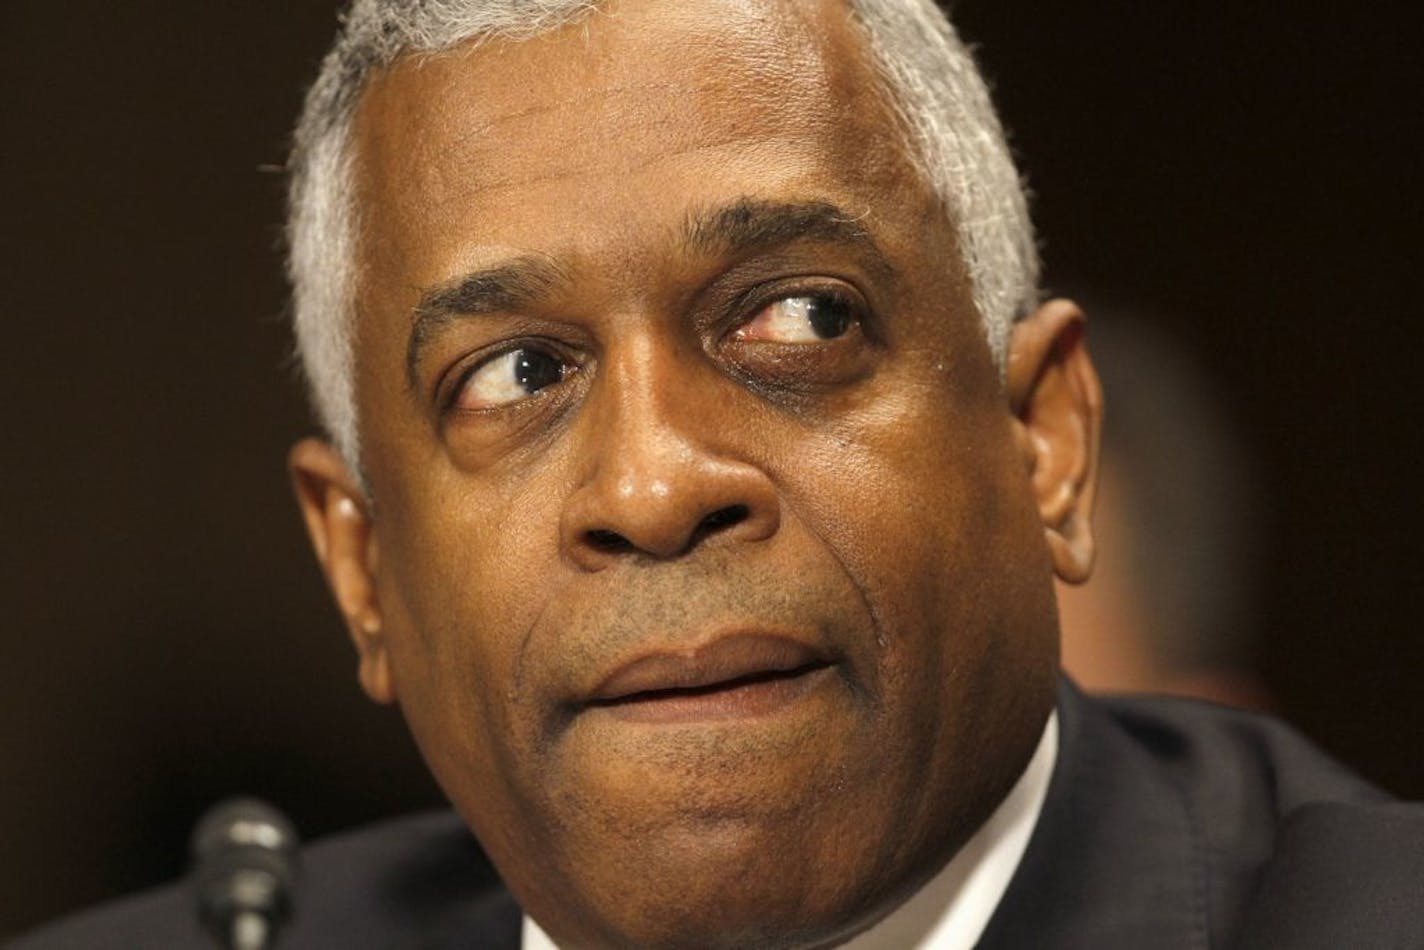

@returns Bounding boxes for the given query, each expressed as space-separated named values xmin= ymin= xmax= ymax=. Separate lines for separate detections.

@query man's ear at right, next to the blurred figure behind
xmin=1008 ymin=301 xmax=1102 ymax=584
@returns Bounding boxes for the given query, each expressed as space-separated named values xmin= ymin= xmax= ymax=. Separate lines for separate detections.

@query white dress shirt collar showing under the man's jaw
xmin=523 ymin=712 xmax=1058 ymax=950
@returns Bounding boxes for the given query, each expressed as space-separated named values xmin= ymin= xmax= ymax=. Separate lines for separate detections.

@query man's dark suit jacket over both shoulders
xmin=16 ymin=684 xmax=1424 ymax=950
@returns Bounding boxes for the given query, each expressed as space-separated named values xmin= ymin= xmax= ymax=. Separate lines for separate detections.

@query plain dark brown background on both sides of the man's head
xmin=0 ymin=0 xmax=1424 ymax=936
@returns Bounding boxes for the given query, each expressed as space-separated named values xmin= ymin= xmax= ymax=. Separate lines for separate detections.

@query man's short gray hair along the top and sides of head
xmin=288 ymin=0 xmax=1038 ymax=471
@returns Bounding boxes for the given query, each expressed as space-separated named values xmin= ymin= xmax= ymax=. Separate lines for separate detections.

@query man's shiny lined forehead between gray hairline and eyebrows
xmin=348 ymin=0 xmax=904 ymax=282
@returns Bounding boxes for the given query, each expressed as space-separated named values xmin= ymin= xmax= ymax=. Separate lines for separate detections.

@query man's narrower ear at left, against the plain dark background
xmin=288 ymin=439 xmax=396 ymax=704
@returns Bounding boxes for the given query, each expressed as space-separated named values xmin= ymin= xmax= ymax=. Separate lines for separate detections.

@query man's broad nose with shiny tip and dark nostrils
xmin=560 ymin=337 xmax=780 ymax=571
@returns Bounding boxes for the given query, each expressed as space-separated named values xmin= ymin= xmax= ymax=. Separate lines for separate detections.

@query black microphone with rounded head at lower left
xmin=192 ymin=798 xmax=299 ymax=950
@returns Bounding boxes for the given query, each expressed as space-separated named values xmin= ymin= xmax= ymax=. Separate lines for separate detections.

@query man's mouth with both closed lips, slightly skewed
xmin=585 ymin=634 xmax=834 ymax=724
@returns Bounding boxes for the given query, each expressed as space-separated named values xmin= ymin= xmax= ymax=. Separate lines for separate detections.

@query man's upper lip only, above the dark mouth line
xmin=590 ymin=632 xmax=832 ymax=704
